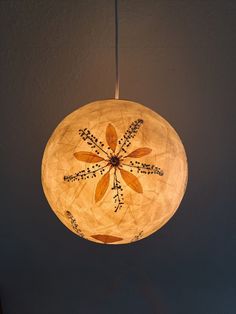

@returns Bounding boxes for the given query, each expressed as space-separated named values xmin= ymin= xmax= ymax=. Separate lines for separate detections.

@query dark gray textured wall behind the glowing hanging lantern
xmin=0 ymin=0 xmax=236 ymax=314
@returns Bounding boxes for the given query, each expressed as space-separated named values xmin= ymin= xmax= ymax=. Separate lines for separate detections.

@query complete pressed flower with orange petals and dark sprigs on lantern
xmin=64 ymin=119 xmax=164 ymax=212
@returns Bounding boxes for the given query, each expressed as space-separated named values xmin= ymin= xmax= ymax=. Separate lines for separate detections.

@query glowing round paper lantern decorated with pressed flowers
xmin=42 ymin=99 xmax=187 ymax=244
